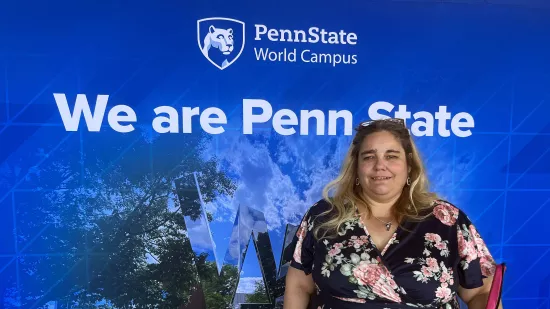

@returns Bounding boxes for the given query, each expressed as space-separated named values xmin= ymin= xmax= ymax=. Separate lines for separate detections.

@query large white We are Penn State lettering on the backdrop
xmin=54 ymin=93 xmax=474 ymax=137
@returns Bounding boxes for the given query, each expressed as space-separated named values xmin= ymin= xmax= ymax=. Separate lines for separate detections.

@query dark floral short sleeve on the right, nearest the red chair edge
xmin=457 ymin=211 xmax=496 ymax=289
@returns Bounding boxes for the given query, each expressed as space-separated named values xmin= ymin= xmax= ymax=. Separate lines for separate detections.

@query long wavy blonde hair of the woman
xmin=313 ymin=118 xmax=438 ymax=238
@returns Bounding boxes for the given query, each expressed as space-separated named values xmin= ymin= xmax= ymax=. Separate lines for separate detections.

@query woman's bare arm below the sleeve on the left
xmin=283 ymin=267 xmax=315 ymax=309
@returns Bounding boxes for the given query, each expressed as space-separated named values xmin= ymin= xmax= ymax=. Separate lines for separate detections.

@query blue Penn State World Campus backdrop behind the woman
xmin=0 ymin=0 xmax=550 ymax=309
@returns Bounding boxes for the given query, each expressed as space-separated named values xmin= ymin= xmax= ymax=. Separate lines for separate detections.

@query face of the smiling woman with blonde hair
xmin=357 ymin=131 xmax=409 ymax=202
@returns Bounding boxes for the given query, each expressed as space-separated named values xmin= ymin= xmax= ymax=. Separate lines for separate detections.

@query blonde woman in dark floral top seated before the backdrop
xmin=284 ymin=119 xmax=502 ymax=309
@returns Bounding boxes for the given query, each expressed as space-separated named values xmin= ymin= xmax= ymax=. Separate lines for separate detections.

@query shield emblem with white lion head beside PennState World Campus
xmin=197 ymin=17 xmax=244 ymax=70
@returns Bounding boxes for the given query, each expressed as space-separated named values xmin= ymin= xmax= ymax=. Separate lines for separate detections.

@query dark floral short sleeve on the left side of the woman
xmin=288 ymin=208 xmax=315 ymax=275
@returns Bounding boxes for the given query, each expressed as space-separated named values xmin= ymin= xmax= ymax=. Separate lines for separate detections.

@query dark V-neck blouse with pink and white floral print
xmin=289 ymin=200 xmax=496 ymax=309
